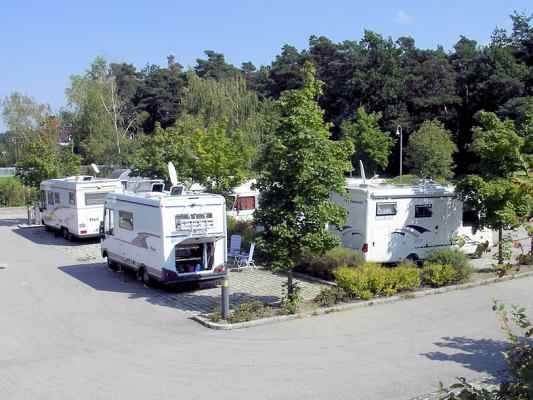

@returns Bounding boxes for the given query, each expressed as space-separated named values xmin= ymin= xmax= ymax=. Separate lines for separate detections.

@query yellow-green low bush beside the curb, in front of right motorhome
xmin=335 ymin=263 xmax=420 ymax=300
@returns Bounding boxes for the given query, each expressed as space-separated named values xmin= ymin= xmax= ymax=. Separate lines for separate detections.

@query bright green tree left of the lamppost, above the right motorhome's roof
xmin=341 ymin=107 xmax=393 ymax=174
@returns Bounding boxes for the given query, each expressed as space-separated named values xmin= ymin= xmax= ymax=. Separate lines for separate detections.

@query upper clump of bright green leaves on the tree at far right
xmin=471 ymin=112 xmax=524 ymax=177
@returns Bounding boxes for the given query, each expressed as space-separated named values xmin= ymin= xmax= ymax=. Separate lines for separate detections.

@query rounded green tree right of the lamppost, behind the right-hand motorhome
xmin=405 ymin=120 xmax=457 ymax=179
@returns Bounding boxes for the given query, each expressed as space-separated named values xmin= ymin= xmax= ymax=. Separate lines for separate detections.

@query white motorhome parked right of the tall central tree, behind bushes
xmin=332 ymin=179 xmax=492 ymax=263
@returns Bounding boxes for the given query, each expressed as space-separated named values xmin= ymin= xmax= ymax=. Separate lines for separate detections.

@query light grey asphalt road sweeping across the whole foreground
xmin=0 ymin=206 xmax=533 ymax=400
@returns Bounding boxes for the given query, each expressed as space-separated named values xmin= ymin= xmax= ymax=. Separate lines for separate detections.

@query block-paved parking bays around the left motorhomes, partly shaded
xmin=9 ymin=209 xmax=322 ymax=315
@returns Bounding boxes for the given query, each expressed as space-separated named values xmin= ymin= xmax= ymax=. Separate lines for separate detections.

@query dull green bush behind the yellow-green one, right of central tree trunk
xmin=298 ymin=247 xmax=365 ymax=280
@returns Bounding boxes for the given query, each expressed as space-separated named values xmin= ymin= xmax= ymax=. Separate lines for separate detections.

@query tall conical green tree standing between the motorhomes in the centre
xmin=255 ymin=64 xmax=351 ymax=280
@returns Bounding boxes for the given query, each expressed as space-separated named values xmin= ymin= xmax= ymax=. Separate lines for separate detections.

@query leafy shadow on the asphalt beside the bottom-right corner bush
xmin=422 ymin=337 xmax=509 ymax=377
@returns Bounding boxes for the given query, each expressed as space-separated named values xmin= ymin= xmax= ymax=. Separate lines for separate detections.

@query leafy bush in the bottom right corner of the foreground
xmin=441 ymin=302 xmax=533 ymax=400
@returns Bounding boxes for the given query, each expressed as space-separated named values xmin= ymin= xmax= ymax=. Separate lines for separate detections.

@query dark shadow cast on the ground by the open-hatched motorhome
xmin=59 ymin=263 xmax=279 ymax=313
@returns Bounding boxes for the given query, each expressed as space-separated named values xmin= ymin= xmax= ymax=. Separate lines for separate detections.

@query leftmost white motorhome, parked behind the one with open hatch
xmin=40 ymin=175 xmax=122 ymax=240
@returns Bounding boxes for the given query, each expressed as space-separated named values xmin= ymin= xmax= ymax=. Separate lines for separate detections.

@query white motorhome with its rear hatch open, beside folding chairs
xmin=101 ymin=191 xmax=227 ymax=284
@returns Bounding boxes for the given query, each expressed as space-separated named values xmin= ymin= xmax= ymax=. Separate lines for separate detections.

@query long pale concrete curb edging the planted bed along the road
xmin=191 ymin=271 xmax=533 ymax=330
